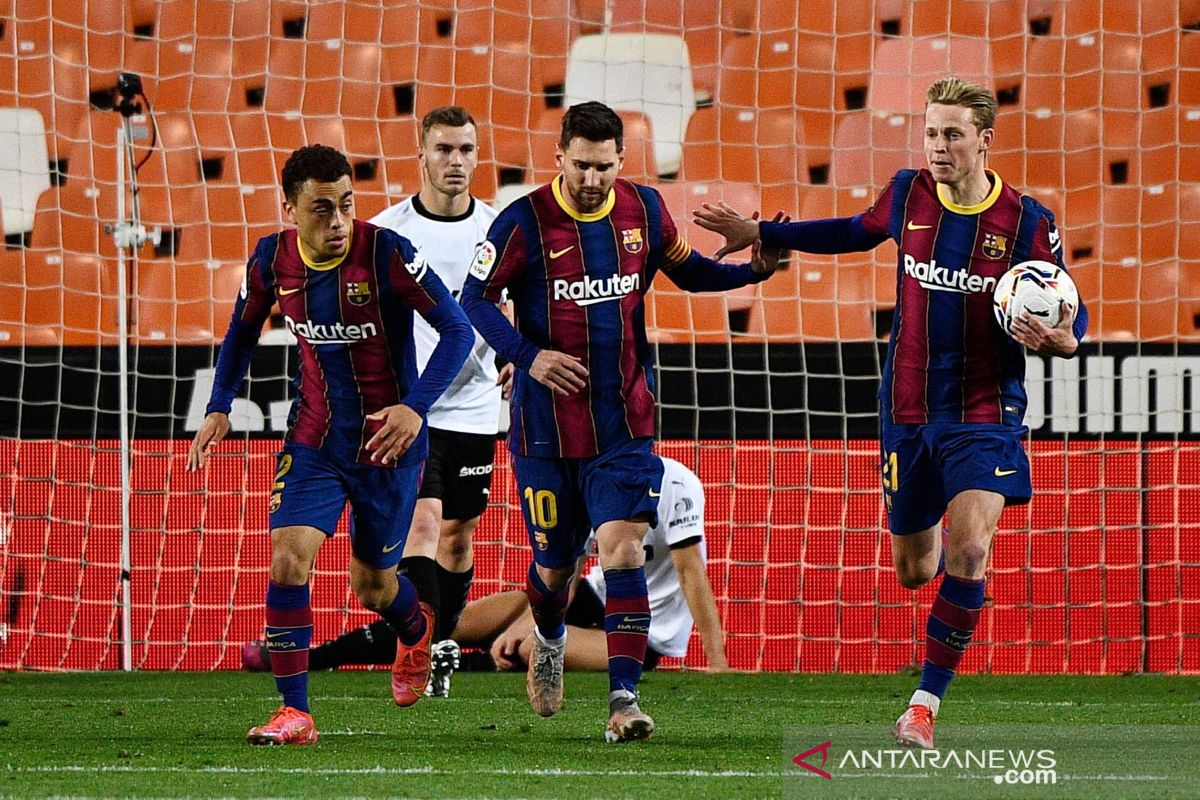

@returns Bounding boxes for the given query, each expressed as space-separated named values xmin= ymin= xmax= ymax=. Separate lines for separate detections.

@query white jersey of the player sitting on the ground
xmin=583 ymin=457 xmax=708 ymax=656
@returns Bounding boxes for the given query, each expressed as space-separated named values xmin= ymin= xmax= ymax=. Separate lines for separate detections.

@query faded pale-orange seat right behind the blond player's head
xmin=866 ymin=36 xmax=991 ymax=114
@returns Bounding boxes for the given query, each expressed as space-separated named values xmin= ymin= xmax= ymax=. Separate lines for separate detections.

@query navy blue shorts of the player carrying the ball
xmin=880 ymin=422 xmax=1033 ymax=536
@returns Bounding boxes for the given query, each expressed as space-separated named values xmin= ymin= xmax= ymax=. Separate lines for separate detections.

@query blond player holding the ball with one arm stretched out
xmin=695 ymin=78 xmax=1087 ymax=747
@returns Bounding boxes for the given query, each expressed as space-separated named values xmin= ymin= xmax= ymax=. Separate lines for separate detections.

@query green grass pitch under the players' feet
xmin=0 ymin=672 xmax=1200 ymax=800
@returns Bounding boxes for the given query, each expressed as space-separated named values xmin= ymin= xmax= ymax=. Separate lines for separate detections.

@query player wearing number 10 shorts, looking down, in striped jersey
xmin=461 ymin=102 xmax=778 ymax=741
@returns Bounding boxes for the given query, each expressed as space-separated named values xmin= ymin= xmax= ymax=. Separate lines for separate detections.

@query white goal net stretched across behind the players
xmin=0 ymin=0 xmax=1200 ymax=673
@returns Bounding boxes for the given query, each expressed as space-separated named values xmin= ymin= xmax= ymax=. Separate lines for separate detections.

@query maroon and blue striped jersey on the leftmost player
xmin=208 ymin=221 xmax=474 ymax=465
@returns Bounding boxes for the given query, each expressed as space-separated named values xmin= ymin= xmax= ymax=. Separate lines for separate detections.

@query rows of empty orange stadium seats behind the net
xmin=0 ymin=0 xmax=1200 ymax=342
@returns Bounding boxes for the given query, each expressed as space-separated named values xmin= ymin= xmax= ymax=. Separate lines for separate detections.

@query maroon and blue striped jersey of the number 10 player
xmin=461 ymin=176 xmax=767 ymax=458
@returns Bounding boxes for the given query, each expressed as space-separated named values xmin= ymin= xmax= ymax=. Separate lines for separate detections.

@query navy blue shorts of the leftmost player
xmin=270 ymin=444 xmax=422 ymax=570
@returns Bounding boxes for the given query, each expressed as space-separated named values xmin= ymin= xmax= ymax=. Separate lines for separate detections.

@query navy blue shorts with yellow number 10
xmin=512 ymin=439 xmax=662 ymax=569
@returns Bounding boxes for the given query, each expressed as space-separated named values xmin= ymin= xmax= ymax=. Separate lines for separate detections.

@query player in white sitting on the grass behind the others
xmin=241 ymin=458 xmax=730 ymax=672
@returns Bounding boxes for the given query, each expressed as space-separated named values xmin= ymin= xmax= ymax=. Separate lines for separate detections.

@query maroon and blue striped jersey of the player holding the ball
xmin=761 ymin=169 xmax=1087 ymax=425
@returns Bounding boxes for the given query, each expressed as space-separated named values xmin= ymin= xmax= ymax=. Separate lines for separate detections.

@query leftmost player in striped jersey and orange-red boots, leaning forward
xmin=187 ymin=145 xmax=473 ymax=745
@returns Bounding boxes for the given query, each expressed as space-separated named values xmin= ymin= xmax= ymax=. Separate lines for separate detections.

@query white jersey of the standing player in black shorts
xmin=371 ymin=194 xmax=500 ymax=435
